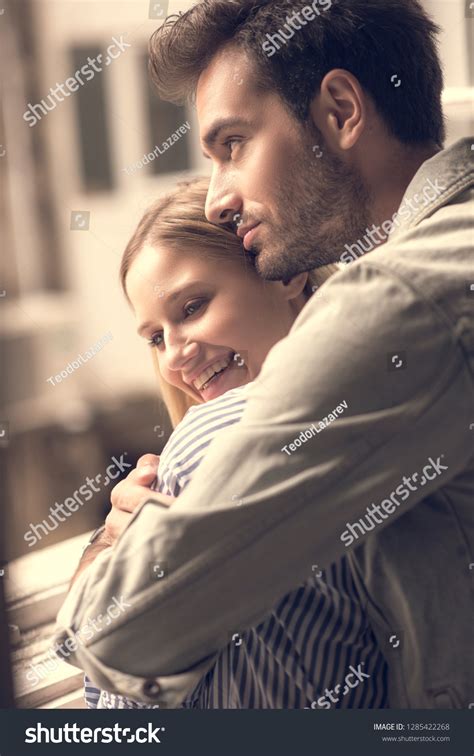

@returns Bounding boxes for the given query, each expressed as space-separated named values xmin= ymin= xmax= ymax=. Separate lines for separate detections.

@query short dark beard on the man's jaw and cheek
xmin=250 ymin=134 xmax=370 ymax=281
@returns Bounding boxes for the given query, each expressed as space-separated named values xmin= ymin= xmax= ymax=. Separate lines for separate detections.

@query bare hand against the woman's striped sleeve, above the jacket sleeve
xmin=105 ymin=454 xmax=174 ymax=545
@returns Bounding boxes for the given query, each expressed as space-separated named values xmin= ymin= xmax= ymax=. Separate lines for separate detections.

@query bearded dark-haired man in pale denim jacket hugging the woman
xmin=58 ymin=0 xmax=474 ymax=708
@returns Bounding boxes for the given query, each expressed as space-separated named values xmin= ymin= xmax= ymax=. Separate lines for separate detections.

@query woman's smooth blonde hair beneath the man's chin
xmin=120 ymin=178 xmax=338 ymax=427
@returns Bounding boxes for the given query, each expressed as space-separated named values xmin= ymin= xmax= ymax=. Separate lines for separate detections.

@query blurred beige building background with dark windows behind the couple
xmin=0 ymin=0 xmax=474 ymax=705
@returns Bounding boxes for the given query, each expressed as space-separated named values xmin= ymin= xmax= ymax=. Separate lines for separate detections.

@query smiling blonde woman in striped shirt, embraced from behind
xmin=86 ymin=179 xmax=386 ymax=708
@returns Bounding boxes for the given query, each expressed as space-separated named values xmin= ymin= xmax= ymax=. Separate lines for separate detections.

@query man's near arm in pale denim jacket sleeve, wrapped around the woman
xmin=53 ymin=261 xmax=473 ymax=705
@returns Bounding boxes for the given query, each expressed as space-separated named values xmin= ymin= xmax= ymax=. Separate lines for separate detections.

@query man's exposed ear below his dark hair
xmin=310 ymin=68 xmax=368 ymax=151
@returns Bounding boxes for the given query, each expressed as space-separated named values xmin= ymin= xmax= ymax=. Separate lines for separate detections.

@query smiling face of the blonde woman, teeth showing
xmin=126 ymin=246 xmax=307 ymax=402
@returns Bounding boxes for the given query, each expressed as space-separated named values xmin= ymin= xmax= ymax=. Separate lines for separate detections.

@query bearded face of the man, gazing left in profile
xmin=196 ymin=47 xmax=367 ymax=280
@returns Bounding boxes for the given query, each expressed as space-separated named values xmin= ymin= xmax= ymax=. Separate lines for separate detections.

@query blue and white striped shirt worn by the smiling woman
xmin=85 ymin=384 xmax=388 ymax=709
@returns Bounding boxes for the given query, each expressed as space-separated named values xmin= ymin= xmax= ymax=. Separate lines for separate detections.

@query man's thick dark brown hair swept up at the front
xmin=150 ymin=0 xmax=445 ymax=146
